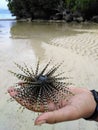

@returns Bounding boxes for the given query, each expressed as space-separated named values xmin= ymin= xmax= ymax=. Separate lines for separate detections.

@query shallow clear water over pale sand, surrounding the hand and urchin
xmin=0 ymin=21 xmax=98 ymax=130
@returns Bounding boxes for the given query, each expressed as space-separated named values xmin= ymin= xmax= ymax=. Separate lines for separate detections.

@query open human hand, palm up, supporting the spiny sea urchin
xmin=8 ymin=87 xmax=96 ymax=125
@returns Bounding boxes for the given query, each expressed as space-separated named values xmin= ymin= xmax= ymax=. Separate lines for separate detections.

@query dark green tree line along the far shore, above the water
xmin=7 ymin=0 xmax=98 ymax=20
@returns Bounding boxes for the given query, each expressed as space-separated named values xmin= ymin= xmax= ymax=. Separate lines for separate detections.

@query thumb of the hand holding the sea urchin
xmin=35 ymin=105 xmax=79 ymax=125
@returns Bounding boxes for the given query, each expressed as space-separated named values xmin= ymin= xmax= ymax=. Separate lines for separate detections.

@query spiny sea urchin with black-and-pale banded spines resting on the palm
xmin=10 ymin=61 xmax=72 ymax=111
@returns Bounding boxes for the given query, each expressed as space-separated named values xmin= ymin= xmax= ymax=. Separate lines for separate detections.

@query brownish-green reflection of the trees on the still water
xmin=11 ymin=22 xmax=83 ymax=40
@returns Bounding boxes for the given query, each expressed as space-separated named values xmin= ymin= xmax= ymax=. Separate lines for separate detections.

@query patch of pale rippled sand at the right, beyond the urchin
xmin=50 ymin=33 xmax=98 ymax=60
